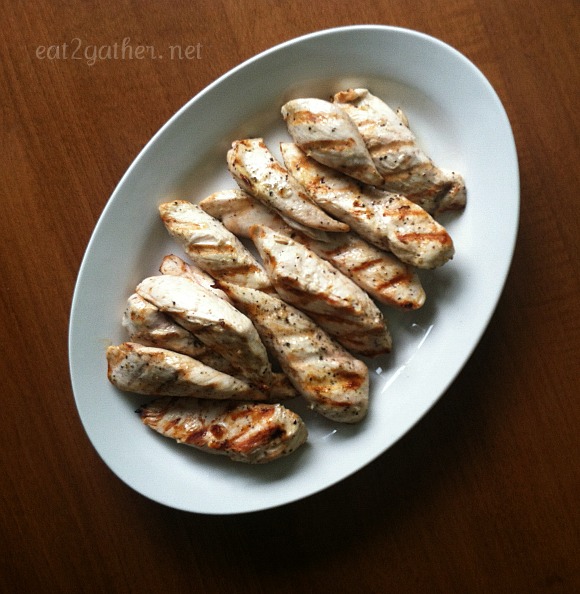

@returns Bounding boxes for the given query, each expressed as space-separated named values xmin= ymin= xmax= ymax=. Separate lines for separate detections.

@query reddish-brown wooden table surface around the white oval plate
xmin=0 ymin=0 xmax=580 ymax=593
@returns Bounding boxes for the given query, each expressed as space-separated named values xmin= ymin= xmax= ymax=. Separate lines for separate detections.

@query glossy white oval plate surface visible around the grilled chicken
xmin=69 ymin=26 xmax=519 ymax=514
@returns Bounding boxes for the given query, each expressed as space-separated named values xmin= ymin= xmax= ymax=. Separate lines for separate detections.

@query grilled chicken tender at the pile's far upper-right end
xmin=334 ymin=89 xmax=466 ymax=214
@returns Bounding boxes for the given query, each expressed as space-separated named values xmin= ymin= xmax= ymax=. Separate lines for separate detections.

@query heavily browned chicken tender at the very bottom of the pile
xmin=137 ymin=398 xmax=308 ymax=464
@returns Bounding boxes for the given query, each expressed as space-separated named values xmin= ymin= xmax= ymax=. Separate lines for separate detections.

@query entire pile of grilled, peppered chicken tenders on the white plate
xmin=107 ymin=89 xmax=466 ymax=463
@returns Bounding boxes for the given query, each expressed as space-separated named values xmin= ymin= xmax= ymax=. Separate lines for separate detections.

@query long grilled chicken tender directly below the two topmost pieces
xmin=281 ymin=143 xmax=454 ymax=268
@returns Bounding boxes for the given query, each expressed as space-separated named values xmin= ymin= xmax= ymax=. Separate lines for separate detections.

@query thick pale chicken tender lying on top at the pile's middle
xmin=250 ymin=225 xmax=392 ymax=357
